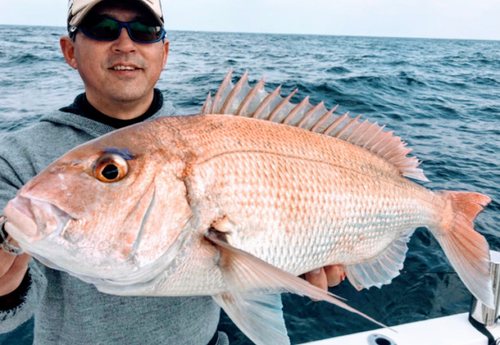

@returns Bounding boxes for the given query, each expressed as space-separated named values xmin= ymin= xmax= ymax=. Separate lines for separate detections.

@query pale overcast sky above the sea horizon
xmin=0 ymin=0 xmax=500 ymax=40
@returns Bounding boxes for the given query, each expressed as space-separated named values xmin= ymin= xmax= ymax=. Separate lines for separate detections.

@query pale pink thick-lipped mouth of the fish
xmin=4 ymin=195 xmax=75 ymax=244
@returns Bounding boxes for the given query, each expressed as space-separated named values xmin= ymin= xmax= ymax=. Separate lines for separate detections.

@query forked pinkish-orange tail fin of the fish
xmin=431 ymin=191 xmax=494 ymax=308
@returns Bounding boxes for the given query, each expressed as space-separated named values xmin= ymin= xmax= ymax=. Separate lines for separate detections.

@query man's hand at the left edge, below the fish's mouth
xmin=0 ymin=238 xmax=31 ymax=296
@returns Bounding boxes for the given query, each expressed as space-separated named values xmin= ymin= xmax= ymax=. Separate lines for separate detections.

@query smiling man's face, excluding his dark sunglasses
xmin=63 ymin=5 xmax=168 ymax=110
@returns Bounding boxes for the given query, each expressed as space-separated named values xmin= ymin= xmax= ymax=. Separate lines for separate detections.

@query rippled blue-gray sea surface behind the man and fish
xmin=0 ymin=26 xmax=500 ymax=345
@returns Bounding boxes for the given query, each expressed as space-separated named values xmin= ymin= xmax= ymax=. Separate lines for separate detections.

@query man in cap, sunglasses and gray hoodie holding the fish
xmin=0 ymin=0 xmax=341 ymax=345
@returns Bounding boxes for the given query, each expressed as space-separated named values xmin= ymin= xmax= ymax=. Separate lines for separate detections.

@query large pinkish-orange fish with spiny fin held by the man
xmin=1 ymin=73 xmax=493 ymax=344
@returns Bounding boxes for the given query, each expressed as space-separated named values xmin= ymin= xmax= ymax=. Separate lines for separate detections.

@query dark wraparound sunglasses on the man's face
xmin=73 ymin=17 xmax=167 ymax=43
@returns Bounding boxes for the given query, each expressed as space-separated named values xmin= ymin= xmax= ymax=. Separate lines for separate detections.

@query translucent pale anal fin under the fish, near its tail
xmin=345 ymin=230 xmax=414 ymax=290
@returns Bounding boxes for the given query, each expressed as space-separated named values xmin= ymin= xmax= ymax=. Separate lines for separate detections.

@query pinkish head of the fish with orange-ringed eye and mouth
xmin=4 ymin=122 xmax=191 ymax=283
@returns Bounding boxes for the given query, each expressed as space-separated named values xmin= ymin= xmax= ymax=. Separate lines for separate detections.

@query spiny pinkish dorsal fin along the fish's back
xmin=201 ymin=70 xmax=428 ymax=181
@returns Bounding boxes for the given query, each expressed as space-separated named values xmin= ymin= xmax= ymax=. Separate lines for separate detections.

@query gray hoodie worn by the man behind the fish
xmin=0 ymin=96 xmax=228 ymax=345
